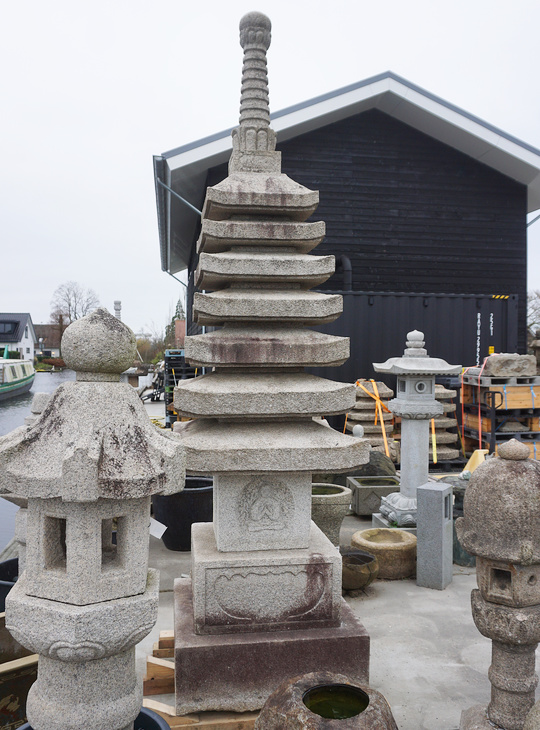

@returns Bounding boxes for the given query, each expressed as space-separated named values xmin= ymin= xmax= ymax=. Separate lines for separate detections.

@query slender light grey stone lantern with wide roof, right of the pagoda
xmin=373 ymin=330 xmax=461 ymax=527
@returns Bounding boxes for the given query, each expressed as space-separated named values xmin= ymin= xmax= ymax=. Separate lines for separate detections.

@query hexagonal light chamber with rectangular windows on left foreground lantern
xmin=26 ymin=497 xmax=150 ymax=605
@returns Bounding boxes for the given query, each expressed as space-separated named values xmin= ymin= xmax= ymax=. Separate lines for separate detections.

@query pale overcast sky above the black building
xmin=0 ymin=0 xmax=540 ymax=332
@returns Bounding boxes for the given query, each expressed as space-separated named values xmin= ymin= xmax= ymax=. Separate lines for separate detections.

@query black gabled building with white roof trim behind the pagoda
xmin=155 ymin=73 xmax=540 ymax=381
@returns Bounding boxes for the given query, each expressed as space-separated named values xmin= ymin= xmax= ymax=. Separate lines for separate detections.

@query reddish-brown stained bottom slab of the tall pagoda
xmin=175 ymin=578 xmax=369 ymax=715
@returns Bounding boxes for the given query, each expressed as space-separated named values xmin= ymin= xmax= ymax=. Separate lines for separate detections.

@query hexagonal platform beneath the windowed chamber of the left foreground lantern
xmin=6 ymin=570 xmax=159 ymax=663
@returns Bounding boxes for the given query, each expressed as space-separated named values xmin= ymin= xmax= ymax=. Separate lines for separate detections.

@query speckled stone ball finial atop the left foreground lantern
xmin=62 ymin=307 xmax=137 ymax=374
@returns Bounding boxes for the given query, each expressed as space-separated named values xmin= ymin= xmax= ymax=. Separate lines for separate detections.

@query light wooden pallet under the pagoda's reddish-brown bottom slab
xmin=143 ymin=631 xmax=259 ymax=730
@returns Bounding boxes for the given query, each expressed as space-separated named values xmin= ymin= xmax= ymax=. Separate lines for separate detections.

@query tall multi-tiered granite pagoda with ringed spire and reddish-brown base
xmin=174 ymin=13 xmax=369 ymax=714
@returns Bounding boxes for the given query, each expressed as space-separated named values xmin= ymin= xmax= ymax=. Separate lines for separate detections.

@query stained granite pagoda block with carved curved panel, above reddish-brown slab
xmin=191 ymin=523 xmax=342 ymax=634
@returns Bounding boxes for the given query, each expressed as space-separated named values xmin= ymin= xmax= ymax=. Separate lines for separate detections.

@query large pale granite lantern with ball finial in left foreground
xmin=0 ymin=309 xmax=184 ymax=730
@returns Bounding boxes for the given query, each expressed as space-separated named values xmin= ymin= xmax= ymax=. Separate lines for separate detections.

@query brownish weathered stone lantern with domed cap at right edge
xmin=456 ymin=439 xmax=540 ymax=730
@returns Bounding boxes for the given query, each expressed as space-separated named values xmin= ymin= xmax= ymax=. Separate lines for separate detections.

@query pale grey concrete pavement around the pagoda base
xmin=137 ymin=392 xmax=536 ymax=730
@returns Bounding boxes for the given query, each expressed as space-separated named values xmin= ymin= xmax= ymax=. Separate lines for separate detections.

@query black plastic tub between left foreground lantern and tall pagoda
xmin=152 ymin=477 xmax=214 ymax=551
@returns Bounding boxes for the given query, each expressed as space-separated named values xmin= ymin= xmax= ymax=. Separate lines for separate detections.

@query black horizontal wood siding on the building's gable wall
xmin=204 ymin=110 xmax=527 ymax=352
